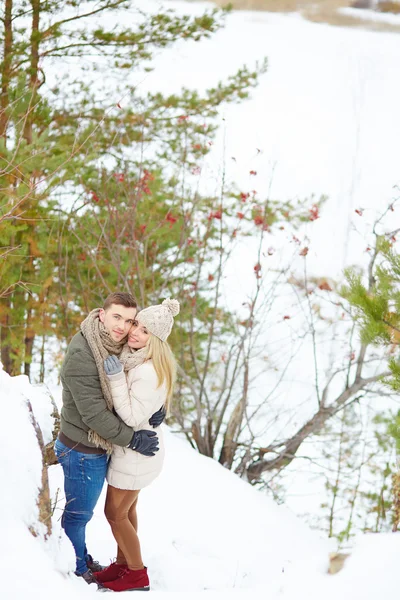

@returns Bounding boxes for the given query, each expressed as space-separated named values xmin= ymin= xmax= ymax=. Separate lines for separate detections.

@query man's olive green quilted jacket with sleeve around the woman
xmin=61 ymin=332 xmax=134 ymax=448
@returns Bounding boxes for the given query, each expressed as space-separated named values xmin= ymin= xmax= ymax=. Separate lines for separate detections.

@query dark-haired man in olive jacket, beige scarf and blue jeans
xmin=55 ymin=293 xmax=165 ymax=583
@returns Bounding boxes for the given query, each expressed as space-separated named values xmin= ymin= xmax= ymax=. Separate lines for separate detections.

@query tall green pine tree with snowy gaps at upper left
xmin=0 ymin=0 xmax=265 ymax=375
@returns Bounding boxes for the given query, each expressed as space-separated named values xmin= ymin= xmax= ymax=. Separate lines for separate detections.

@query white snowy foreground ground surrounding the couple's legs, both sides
xmin=0 ymin=371 xmax=400 ymax=600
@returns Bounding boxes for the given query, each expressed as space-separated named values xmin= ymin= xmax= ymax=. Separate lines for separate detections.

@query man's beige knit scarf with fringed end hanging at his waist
xmin=81 ymin=308 xmax=124 ymax=454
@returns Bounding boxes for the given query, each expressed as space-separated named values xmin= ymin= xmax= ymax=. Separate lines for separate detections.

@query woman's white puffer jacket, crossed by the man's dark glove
xmin=107 ymin=360 xmax=167 ymax=490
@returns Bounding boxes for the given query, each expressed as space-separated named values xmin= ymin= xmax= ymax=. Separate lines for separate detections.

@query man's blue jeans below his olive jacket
xmin=54 ymin=439 xmax=108 ymax=574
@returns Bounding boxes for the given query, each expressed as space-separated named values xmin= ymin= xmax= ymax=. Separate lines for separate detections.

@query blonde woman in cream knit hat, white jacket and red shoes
xmin=95 ymin=298 xmax=179 ymax=592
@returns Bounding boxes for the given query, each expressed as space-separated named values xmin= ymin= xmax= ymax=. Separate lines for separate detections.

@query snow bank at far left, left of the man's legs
xmin=0 ymin=370 xmax=87 ymax=600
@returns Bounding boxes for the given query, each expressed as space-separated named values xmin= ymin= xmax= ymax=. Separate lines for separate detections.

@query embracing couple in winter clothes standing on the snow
xmin=55 ymin=293 xmax=179 ymax=592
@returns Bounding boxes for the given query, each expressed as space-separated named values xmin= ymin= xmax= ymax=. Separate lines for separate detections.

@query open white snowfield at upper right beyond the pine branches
xmin=139 ymin=1 xmax=400 ymax=286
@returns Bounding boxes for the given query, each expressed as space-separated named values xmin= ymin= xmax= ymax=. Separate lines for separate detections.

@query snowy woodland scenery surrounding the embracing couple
xmin=0 ymin=0 xmax=400 ymax=600
